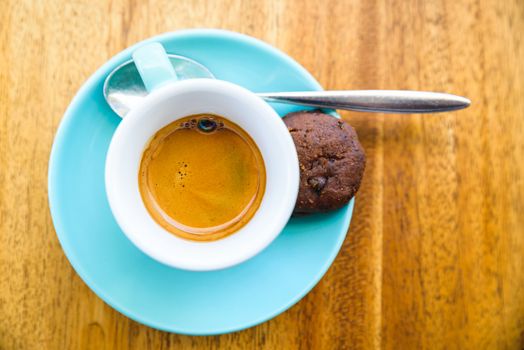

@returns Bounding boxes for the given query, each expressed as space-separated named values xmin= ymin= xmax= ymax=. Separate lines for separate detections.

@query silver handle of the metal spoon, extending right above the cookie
xmin=257 ymin=90 xmax=471 ymax=113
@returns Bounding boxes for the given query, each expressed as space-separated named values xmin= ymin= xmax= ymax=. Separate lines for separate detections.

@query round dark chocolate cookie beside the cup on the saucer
xmin=283 ymin=111 xmax=366 ymax=214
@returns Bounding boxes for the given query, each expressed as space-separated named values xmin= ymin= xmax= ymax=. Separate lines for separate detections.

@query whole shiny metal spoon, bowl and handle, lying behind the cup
xmin=104 ymin=54 xmax=471 ymax=118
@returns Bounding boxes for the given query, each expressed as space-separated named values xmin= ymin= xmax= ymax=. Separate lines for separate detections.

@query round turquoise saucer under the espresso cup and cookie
xmin=49 ymin=30 xmax=353 ymax=335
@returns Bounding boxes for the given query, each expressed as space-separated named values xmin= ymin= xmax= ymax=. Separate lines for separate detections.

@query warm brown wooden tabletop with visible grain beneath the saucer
xmin=0 ymin=0 xmax=524 ymax=350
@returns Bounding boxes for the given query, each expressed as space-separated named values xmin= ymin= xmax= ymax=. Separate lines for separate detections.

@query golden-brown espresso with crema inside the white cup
xmin=138 ymin=114 xmax=266 ymax=241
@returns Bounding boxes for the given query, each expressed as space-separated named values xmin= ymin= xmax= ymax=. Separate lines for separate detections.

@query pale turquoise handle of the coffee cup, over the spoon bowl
xmin=132 ymin=43 xmax=178 ymax=92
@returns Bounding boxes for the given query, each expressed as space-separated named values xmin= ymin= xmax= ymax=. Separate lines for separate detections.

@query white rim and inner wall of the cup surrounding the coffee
xmin=105 ymin=79 xmax=299 ymax=271
